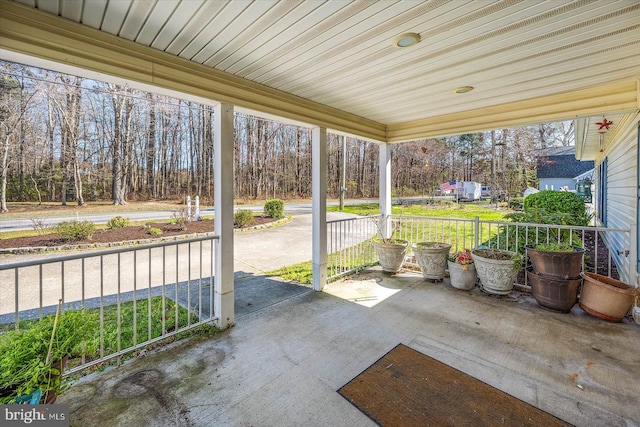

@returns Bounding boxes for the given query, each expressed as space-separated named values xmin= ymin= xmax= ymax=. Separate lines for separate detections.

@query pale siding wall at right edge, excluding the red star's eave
xmin=596 ymin=113 xmax=640 ymax=285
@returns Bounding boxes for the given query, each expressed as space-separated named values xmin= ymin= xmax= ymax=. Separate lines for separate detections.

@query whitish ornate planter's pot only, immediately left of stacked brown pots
xmin=471 ymin=250 xmax=518 ymax=295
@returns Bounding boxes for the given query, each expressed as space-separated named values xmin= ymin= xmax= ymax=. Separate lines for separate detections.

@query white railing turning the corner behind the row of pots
xmin=327 ymin=215 xmax=635 ymax=285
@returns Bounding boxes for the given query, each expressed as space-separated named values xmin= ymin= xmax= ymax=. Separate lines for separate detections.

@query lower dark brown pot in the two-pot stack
xmin=527 ymin=269 xmax=582 ymax=313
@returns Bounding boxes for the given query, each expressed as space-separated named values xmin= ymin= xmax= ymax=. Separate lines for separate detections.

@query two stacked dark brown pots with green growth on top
xmin=526 ymin=242 xmax=584 ymax=313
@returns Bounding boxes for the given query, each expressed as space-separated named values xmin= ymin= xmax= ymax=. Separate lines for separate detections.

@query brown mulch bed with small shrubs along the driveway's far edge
xmin=0 ymin=216 xmax=275 ymax=249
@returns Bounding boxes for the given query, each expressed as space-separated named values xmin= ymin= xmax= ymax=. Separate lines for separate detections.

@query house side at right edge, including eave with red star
xmin=575 ymin=110 xmax=640 ymax=285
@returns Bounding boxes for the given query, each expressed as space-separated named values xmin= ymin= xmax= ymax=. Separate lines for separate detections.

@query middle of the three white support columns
xmin=311 ymin=127 xmax=327 ymax=291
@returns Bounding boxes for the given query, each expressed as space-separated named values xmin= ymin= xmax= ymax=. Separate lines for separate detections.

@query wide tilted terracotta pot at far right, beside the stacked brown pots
xmin=579 ymin=273 xmax=638 ymax=322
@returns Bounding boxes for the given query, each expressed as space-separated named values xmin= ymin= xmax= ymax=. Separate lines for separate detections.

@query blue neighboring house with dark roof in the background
xmin=538 ymin=146 xmax=594 ymax=191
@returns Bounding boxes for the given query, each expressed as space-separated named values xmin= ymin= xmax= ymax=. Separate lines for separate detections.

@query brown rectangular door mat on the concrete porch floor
xmin=338 ymin=344 xmax=571 ymax=427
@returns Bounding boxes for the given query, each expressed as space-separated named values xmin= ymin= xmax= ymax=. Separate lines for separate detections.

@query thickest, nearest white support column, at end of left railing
xmin=213 ymin=104 xmax=234 ymax=329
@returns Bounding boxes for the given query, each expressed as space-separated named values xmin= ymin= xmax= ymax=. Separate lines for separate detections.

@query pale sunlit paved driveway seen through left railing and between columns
xmin=0 ymin=213 xmax=360 ymax=315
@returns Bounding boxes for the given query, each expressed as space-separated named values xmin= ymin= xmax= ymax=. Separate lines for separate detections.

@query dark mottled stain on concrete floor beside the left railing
xmin=59 ymin=337 xmax=227 ymax=427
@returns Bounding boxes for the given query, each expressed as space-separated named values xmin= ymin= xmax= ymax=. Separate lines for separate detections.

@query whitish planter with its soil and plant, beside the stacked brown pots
xmin=471 ymin=248 xmax=522 ymax=295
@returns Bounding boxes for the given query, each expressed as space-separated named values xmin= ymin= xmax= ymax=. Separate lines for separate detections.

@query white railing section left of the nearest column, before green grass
xmin=0 ymin=236 xmax=218 ymax=375
